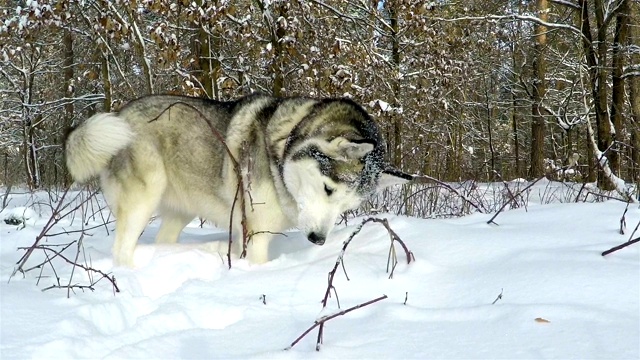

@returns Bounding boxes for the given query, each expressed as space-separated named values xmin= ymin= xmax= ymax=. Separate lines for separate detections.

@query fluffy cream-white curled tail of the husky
xmin=65 ymin=113 xmax=135 ymax=182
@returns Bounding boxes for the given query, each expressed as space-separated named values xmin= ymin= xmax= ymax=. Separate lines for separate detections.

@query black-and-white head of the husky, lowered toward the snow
xmin=282 ymin=100 xmax=412 ymax=245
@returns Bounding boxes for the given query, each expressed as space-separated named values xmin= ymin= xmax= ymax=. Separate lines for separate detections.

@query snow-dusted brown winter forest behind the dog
xmin=0 ymin=0 xmax=640 ymax=194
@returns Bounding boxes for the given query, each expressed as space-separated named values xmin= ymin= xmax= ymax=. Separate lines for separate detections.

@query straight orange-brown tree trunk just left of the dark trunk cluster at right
xmin=529 ymin=0 xmax=549 ymax=179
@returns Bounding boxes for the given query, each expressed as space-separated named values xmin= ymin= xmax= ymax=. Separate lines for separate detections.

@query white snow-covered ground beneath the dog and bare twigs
xmin=0 ymin=187 xmax=640 ymax=359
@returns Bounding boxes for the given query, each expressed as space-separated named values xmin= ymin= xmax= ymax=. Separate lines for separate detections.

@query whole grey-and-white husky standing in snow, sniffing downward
xmin=65 ymin=95 xmax=411 ymax=266
